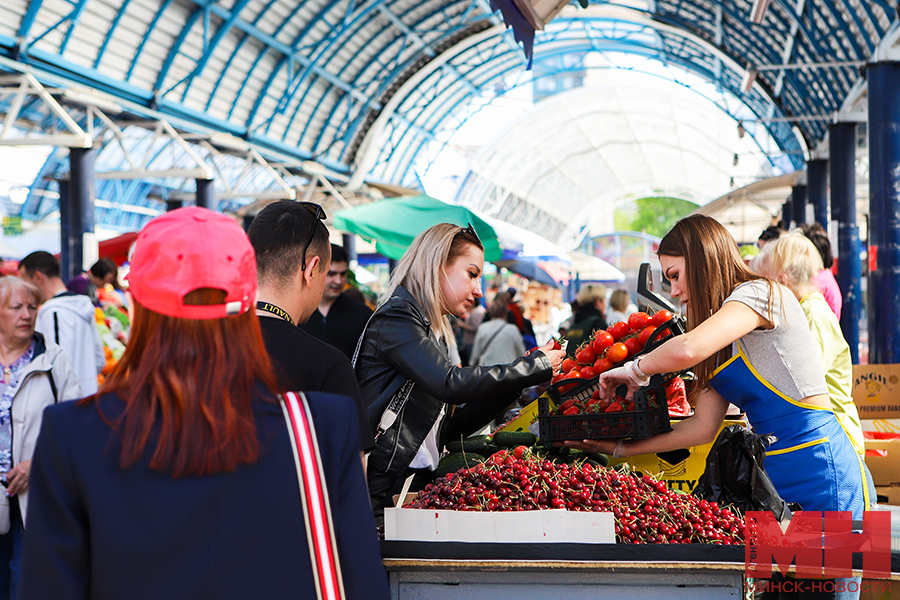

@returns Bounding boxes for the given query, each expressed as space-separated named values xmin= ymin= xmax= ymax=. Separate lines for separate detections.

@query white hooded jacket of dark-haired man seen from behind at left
xmin=34 ymin=293 xmax=106 ymax=396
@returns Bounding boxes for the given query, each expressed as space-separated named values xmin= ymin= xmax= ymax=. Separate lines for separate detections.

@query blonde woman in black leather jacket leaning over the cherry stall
xmin=354 ymin=223 xmax=564 ymax=509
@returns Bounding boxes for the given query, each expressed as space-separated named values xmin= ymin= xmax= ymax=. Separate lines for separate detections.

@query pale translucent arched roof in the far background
xmin=456 ymin=82 xmax=780 ymax=247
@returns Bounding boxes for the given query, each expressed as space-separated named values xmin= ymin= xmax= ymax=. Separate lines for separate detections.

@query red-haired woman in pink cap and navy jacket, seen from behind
xmin=20 ymin=207 xmax=389 ymax=600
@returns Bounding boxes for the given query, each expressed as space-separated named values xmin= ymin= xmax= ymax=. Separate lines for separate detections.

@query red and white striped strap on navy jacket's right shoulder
xmin=281 ymin=392 xmax=344 ymax=600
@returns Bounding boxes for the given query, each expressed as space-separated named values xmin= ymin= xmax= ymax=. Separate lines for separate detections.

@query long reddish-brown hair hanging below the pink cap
xmin=90 ymin=289 xmax=280 ymax=478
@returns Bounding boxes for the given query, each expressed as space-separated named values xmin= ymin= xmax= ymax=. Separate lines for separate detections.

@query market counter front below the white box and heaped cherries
xmin=382 ymin=541 xmax=900 ymax=600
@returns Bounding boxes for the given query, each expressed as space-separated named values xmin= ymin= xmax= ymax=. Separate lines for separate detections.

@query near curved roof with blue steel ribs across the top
xmin=0 ymin=0 xmax=897 ymax=230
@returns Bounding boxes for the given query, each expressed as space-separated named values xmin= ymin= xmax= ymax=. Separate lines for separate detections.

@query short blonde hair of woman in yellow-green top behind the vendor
xmin=750 ymin=229 xmax=825 ymax=294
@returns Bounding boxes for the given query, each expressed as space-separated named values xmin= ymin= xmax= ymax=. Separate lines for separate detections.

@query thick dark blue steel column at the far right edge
xmin=866 ymin=62 xmax=900 ymax=364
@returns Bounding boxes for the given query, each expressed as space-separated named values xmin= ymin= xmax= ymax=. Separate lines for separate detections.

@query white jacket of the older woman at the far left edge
xmin=0 ymin=333 xmax=81 ymax=533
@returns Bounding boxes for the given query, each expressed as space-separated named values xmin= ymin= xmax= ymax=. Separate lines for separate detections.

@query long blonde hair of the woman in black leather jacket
xmin=381 ymin=223 xmax=484 ymax=346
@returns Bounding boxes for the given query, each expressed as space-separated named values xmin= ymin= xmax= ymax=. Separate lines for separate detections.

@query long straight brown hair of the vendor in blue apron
xmin=656 ymin=214 xmax=774 ymax=387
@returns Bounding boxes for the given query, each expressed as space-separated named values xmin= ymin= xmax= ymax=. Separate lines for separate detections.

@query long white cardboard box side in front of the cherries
xmin=384 ymin=508 xmax=616 ymax=544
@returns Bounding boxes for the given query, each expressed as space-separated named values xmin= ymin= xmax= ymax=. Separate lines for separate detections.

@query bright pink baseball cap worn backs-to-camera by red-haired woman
xmin=127 ymin=206 xmax=256 ymax=319
